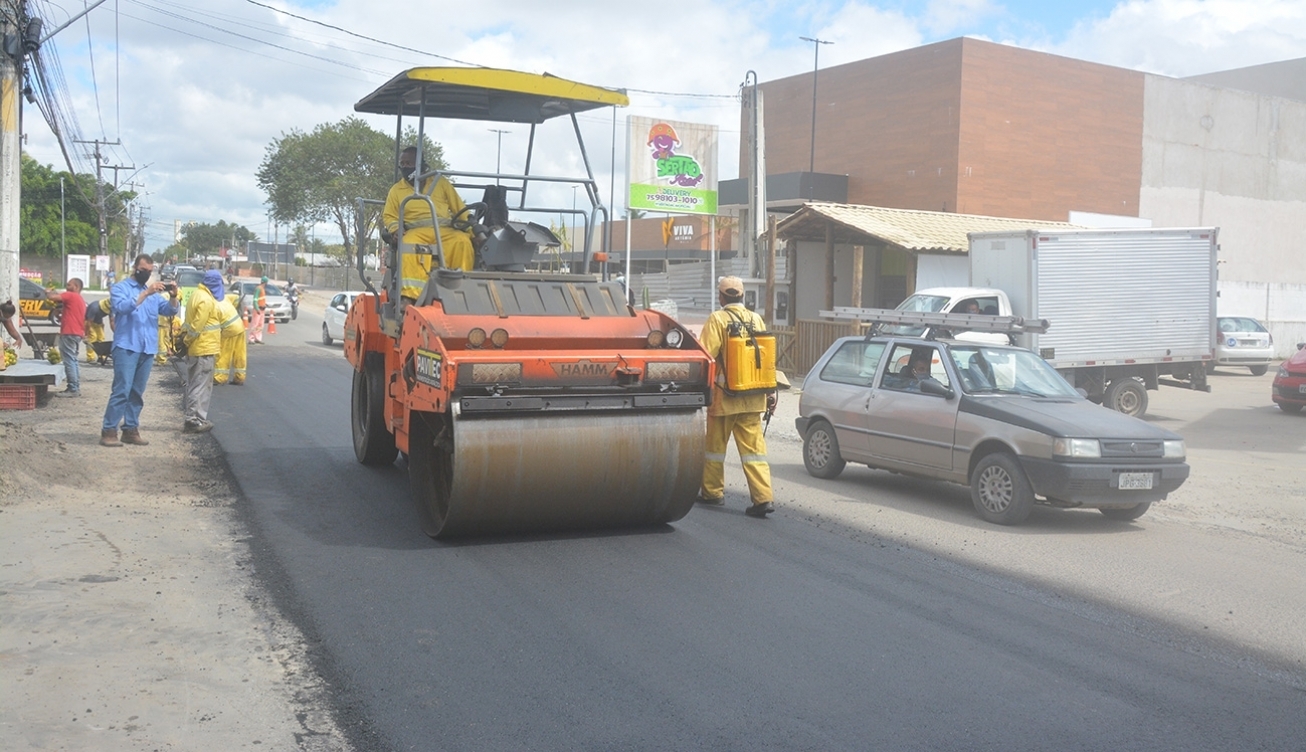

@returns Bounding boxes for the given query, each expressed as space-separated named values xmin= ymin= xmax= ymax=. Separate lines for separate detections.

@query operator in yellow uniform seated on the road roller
xmin=381 ymin=146 xmax=475 ymax=300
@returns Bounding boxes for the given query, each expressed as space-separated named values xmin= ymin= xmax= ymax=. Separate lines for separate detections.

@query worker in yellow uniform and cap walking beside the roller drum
xmin=699 ymin=277 xmax=776 ymax=517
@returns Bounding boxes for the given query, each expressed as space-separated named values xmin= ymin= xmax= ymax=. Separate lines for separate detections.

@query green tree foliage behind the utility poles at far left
xmin=18 ymin=154 xmax=136 ymax=257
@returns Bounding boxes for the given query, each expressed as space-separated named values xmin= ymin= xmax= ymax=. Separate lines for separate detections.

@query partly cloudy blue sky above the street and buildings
xmin=24 ymin=0 xmax=1306 ymax=252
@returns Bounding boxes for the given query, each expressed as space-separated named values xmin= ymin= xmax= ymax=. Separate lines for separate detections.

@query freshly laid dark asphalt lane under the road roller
xmin=213 ymin=315 xmax=1306 ymax=751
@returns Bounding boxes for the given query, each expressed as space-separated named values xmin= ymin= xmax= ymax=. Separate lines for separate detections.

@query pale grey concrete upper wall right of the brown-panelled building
xmin=1139 ymin=76 xmax=1306 ymax=287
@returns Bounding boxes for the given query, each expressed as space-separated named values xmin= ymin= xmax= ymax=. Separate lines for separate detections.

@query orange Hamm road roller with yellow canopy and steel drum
xmin=343 ymin=68 xmax=714 ymax=538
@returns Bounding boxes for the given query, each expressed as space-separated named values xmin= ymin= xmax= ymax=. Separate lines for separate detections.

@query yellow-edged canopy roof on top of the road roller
xmin=354 ymin=68 xmax=629 ymax=123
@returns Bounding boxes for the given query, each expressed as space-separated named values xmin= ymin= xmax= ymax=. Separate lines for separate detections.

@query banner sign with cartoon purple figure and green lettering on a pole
xmin=626 ymin=115 xmax=717 ymax=214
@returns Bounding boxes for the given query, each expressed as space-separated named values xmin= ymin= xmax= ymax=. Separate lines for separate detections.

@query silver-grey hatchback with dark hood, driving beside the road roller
xmin=797 ymin=337 xmax=1188 ymax=525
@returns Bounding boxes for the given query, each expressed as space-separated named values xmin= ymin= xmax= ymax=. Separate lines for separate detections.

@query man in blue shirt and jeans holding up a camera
xmin=99 ymin=253 xmax=178 ymax=447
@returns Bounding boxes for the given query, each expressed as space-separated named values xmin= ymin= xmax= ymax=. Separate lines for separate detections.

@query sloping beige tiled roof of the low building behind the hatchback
xmin=777 ymin=201 xmax=1079 ymax=253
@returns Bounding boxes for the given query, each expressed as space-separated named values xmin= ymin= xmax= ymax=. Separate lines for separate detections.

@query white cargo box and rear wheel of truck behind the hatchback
xmin=966 ymin=227 xmax=1218 ymax=415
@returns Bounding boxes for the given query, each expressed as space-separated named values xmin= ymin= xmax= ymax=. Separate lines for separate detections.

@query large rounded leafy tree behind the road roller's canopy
xmin=257 ymin=116 xmax=445 ymax=256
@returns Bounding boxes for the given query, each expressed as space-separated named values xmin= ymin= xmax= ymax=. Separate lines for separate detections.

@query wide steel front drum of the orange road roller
xmin=410 ymin=410 xmax=707 ymax=538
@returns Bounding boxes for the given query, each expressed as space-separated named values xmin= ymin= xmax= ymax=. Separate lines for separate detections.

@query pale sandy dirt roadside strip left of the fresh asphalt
xmin=0 ymin=355 xmax=350 ymax=752
